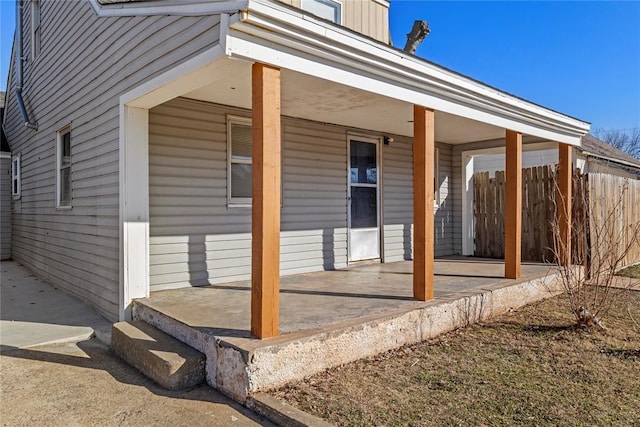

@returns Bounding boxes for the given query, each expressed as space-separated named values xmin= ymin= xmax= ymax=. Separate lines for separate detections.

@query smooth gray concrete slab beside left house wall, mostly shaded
xmin=0 ymin=261 xmax=111 ymax=352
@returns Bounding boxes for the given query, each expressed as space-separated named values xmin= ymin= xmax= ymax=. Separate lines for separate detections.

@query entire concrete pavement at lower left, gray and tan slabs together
xmin=0 ymin=261 xmax=273 ymax=427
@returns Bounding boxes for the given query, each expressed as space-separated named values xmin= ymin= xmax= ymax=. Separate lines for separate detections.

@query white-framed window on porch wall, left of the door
xmin=227 ymin=116 xmax=253 ymax=205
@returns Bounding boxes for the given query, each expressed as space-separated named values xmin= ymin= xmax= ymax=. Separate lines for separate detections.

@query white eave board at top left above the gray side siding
xmin=88 ymin=0 xmax=247 ymax=18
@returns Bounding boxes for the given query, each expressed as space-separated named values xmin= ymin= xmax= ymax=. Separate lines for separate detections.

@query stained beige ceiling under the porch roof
xmin=184 ymin=58 xmax=504 ymax=144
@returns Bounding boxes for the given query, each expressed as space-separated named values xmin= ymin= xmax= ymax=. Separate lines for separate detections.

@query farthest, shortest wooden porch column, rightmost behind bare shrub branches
xmin=556 ymin=144 xmax=573 ymax=265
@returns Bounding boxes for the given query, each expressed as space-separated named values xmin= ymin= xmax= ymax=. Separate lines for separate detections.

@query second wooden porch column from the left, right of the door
xmin=413 ymin=105 xmax=435 ymax=301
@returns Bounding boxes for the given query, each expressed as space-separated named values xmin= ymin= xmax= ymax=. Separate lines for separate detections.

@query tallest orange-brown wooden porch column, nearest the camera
xmin=251 ymin=63 xmax=281 ymax=338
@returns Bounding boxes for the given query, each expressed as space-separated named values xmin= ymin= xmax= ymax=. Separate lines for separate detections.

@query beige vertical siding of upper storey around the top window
xmin=279 ymin=0 xmax=389 ymax=44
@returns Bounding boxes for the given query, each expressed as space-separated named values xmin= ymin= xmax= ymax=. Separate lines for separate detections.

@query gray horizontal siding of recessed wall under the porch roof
xmin=149 ymin=98 xmax=452 ymax=290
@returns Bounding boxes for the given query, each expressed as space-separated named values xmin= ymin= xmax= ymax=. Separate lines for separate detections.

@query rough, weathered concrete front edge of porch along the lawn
xmin=240 ymin=274 xmax=562 ymax=393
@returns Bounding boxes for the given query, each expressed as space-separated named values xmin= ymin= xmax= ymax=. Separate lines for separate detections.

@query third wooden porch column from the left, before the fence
xmin=504 ymin=130 xmax=522 ymax=279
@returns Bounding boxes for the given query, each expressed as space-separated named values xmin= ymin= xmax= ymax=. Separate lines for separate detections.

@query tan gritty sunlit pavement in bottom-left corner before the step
xmin=0 ymin=339 xmax=271 ymax=427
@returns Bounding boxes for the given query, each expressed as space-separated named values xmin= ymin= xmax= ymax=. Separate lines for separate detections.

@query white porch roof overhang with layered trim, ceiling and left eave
xmin=109 ymin=0 xmax=589 ymax=146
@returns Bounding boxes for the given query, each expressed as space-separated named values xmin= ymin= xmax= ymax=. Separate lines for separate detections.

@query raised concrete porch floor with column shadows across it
xmin=140 ymin=257 xmax=550 ymax=338
